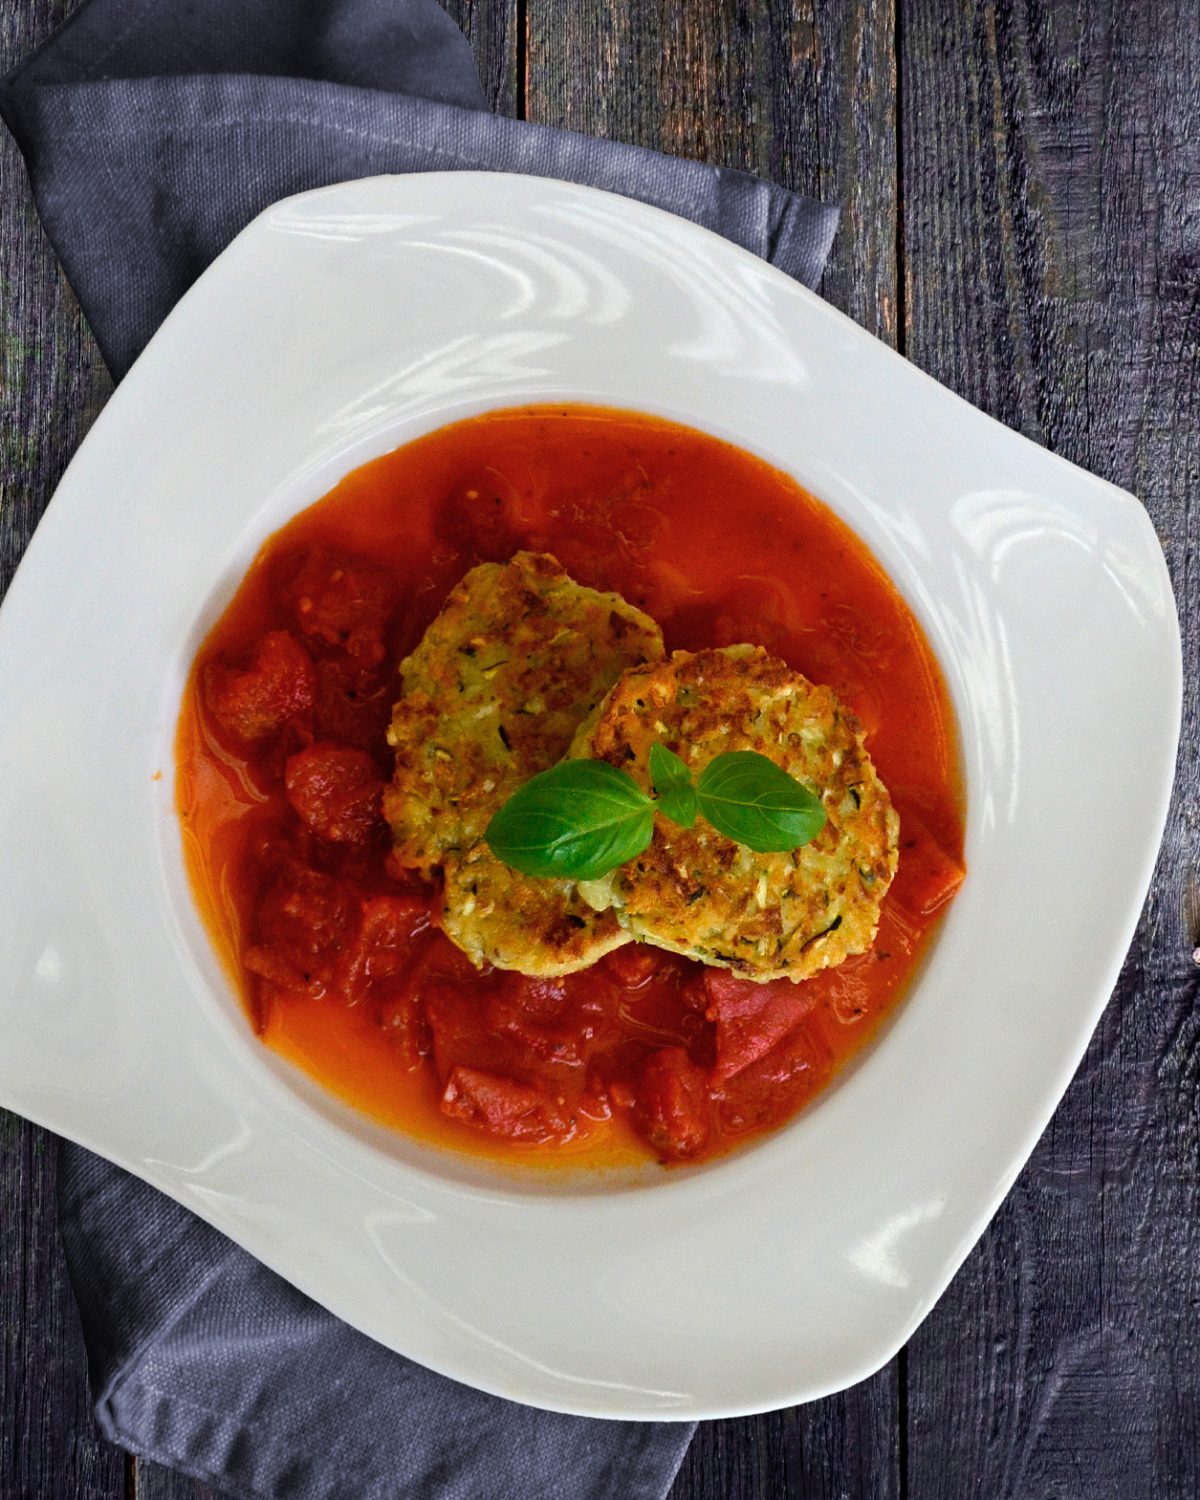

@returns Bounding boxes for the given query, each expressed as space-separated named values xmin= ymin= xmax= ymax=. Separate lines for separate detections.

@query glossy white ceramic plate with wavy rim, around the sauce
xmin=0 ymin=174 xmax=1181 ymax=1418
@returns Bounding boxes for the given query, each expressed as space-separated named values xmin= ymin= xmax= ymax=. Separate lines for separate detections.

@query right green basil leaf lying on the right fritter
xmin=696 ymin=750 xmax=825 ymax=854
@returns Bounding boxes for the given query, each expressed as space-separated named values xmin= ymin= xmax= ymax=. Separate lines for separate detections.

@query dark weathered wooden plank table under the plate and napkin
xmin=0 ymin=0 xmax=1200 ymax=1500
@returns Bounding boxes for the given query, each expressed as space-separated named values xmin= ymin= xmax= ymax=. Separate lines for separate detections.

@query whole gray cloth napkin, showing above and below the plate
xmin=0 ymin=0 xmax=837 ymax=1500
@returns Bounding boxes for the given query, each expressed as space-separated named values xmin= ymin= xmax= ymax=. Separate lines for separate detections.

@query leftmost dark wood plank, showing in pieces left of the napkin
xmin=0 ymin=0 xmax=126 ymax=1500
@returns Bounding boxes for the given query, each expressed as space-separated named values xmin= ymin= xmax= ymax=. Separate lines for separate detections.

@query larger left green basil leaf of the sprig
xmin=483 ymin=761 xmax=654 ymax=881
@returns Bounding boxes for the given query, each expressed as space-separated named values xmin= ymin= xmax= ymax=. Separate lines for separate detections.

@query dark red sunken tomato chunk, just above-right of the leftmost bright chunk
xmin=279 ymin=548 xmax=396 ymax=666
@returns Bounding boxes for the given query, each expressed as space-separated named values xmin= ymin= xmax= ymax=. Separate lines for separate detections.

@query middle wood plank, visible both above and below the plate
xmin=525 ymin=0 xmax=899 ymax=1500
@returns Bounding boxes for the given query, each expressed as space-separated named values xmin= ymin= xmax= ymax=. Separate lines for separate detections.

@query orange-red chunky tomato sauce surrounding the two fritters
xmin=176 ymin=407 xmax=963 ymax=1166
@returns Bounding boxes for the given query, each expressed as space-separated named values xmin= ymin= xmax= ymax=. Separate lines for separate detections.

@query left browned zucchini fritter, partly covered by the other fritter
xmin=384 ymin=552 xmax=663 ymax=975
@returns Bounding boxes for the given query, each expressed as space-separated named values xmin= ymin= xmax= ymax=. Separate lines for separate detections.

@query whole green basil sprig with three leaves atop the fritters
xmin=483 ymin=744 xmax=825 ymax=881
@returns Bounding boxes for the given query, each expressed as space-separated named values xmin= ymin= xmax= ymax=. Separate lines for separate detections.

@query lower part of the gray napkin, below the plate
xmin=59 ymin=1146 xmax=693 ymax=1500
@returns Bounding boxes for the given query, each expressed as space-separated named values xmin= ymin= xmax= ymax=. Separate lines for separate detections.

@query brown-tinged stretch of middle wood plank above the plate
xmin=525 ymin=0 xmax=897 ymax=342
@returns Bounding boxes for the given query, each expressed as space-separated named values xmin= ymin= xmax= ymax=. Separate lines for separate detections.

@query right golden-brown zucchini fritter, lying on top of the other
xmin=570 ymin=647 xmax=899 ymax=981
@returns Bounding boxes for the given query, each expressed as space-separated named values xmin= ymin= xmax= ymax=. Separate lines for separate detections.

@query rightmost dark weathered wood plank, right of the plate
xmin=900 ymin=0 xmax=1200 ymax=1500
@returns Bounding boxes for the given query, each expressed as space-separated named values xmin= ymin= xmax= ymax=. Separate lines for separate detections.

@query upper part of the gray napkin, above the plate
xmin=0 ymin=0 xmax=837 ymax=378
